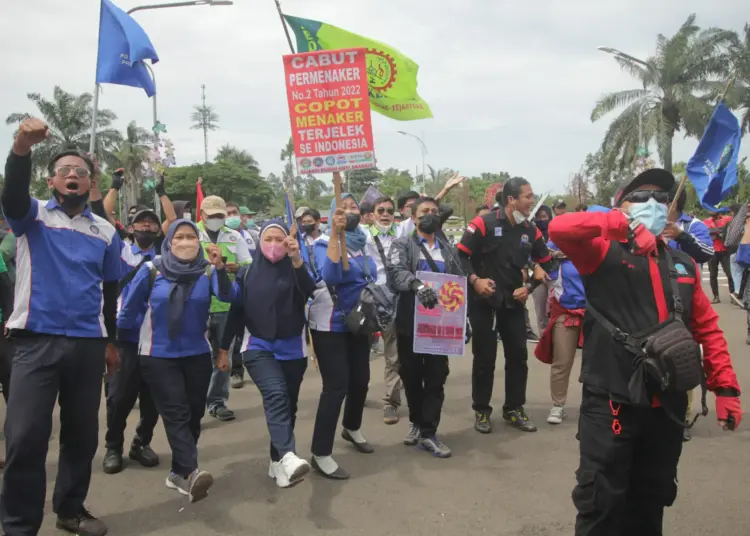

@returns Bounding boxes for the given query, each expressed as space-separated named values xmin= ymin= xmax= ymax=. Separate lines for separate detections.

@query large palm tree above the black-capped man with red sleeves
xmin=591 ymin=15 xmax=732 ymax=173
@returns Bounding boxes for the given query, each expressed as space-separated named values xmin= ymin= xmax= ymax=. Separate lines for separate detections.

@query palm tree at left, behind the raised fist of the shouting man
xmin=5 ymin=86 xmax=122 ymax=177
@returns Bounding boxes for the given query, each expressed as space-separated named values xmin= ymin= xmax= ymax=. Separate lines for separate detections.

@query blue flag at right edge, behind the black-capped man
xmin=687 ymin=102 xmax=742 ymax=212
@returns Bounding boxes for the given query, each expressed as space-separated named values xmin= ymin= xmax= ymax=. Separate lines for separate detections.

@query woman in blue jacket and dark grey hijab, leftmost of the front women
xmin=117 ymin=219 xmax=233 ymax=502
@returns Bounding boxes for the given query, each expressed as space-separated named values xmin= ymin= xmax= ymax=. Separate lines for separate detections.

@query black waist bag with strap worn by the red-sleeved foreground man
xmin=586 ymin=250 xmax=708 ymax=428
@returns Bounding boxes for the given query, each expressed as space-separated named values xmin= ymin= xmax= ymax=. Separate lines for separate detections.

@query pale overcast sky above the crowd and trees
xmin=0 ymin=0 xmax=750 ymax=191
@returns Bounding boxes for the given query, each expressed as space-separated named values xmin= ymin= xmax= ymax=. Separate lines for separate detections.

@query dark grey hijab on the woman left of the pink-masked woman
xmin=154 ymin=219 xmax=208 ymax=339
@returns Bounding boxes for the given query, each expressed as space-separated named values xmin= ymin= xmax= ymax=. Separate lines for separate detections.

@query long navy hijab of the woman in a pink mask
xmin=242 ymin=220 xmax=305 ymax=341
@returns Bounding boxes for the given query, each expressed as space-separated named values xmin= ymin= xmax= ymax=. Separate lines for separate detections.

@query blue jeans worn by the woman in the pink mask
xmin=243 ymin=350 xmax=307 ymax=462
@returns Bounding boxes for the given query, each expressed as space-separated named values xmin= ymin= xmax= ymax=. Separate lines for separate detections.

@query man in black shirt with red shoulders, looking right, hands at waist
xmin=458 ymin=178 xmax=557 ymax=434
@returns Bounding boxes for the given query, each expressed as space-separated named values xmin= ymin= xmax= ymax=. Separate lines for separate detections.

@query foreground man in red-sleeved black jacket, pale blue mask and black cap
xmin=549 ymin=169 xmax=742 ymax=536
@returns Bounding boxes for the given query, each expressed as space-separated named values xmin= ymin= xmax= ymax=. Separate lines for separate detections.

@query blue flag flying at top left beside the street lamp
xmin=96 ymin=0 xmax=159 ymax=97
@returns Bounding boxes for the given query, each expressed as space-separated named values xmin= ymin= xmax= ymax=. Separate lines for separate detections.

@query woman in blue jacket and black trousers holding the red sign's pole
xmin=310 ymin=193 xmax=377 ymax=480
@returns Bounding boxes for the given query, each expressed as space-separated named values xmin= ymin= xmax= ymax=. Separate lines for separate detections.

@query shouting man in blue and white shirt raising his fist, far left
xmin=0 ymin=118 xmax=122 ymax=536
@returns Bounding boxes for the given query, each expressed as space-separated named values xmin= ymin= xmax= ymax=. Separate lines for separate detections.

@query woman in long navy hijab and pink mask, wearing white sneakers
xmin=221 ymin=220 xmax=315 ymax=488
